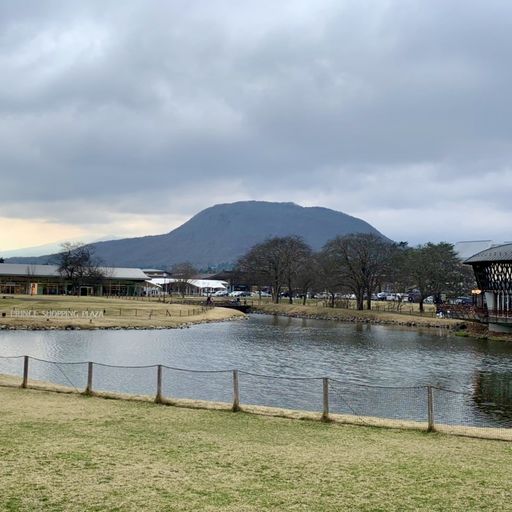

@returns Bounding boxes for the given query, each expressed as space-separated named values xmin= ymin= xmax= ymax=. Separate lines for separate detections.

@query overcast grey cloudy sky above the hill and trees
xmin=0 ymin=0 xmax=512 ymax=251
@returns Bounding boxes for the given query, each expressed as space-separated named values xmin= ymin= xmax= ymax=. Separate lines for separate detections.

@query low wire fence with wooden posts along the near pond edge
xmin=0 ymin=356 xmax=512 ymax=440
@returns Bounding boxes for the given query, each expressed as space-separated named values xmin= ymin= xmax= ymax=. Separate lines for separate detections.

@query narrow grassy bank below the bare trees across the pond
xmin=253 ymin=302 xmax=464 ymax=329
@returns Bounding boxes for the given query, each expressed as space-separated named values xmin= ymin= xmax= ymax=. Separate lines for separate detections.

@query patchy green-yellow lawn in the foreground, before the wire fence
xmin=0 ymin=387 xmax=512 ymax=512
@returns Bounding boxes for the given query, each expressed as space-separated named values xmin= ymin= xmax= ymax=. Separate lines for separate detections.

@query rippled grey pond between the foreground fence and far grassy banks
xmin=0 ymin=315 xmax=512 ymax=428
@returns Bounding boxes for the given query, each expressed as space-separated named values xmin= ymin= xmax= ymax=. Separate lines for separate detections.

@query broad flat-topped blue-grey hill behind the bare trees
xmin=6 ymin=201 xmax=383 ymax=269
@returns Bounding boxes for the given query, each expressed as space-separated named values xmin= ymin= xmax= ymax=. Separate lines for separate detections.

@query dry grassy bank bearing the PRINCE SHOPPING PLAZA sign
xmin=0 ymin=295 xmax=244 ymax=329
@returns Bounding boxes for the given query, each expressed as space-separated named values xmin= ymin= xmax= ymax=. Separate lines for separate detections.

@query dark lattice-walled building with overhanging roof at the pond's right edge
xmin=464 ymin=243 xmax=512 ymax=332
